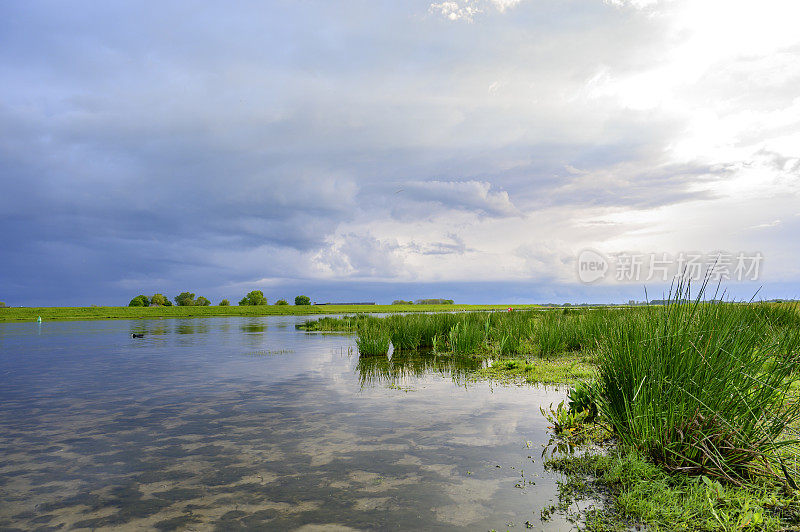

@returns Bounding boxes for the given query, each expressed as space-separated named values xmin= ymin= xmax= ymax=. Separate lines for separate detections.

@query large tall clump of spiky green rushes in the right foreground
xmin=598 ymin=284 xmax=800 ymax=482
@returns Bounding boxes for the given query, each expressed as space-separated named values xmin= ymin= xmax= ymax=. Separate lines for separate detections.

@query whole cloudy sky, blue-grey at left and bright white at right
xmin=0 ymin=0 xmax=800 ymax=306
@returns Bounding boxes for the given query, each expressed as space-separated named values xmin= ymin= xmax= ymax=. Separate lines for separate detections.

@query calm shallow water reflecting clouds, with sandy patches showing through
xmin=0 ymin=316 xmax=570 ymax=530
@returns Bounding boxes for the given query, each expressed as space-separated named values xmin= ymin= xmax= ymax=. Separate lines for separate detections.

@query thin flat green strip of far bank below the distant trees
xmin=0 ymin=305 xmax=540 ymax=322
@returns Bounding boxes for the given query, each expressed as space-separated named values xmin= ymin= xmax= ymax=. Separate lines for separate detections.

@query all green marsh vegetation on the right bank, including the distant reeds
xmin=298 ymin=284 xmax=800 ymax=530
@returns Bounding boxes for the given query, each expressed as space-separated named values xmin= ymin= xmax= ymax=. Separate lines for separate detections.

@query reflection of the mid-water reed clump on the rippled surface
xmin=356 ymin=352 xmax=485 ymax=388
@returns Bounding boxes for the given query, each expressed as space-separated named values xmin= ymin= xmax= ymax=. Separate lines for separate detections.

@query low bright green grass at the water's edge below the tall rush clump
xmin=542 ymin=449 xmax=800 ymax=531
